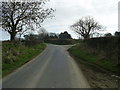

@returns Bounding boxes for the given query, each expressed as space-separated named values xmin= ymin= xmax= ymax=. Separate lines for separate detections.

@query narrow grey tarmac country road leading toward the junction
xmin=2 ymin=44 xmax=90 ymax=88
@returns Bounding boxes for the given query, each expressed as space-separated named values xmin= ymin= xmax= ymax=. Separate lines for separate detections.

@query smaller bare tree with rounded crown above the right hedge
xmin=71 ymin=17 xmax=103 ymax=39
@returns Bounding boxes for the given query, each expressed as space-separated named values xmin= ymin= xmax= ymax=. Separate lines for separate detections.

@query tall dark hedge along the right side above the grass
xmin=83 ymin=37 xmax=120 ymax=65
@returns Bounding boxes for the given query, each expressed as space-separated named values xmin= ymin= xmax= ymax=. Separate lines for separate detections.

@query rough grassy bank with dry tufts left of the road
xmin=2 ymin=43 xmax=46 ymax=77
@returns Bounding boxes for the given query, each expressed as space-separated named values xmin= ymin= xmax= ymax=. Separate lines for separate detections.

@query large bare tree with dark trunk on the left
xmin=0 ymin=0 xmax=54 ymax=40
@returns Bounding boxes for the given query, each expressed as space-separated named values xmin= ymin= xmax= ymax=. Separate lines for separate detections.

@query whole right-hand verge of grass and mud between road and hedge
xmin=68 ymin=45 xmax=120 ymax=88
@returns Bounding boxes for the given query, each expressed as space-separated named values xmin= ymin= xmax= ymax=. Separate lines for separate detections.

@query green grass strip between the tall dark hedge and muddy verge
xmin=69 ymin=44 xmax=120 ymax=73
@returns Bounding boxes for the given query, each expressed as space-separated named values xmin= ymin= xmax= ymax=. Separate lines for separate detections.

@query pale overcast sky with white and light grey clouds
xmin=2 ymin=0 xmax=119 ymax=39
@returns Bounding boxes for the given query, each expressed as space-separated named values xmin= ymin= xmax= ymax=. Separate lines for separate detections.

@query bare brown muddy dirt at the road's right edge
xmin=76 ymin=62 xmax=120 ymax=88
